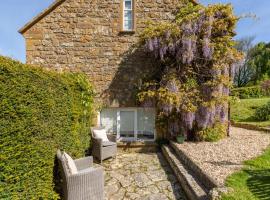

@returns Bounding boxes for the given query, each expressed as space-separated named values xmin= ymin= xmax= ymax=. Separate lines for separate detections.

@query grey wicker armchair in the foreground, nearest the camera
xmin=57 ymin=150 xmax=104 ymax=200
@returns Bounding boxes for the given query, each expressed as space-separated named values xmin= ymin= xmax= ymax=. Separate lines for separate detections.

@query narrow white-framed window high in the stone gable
xmin=122 ymin=0 xmax=134 ymax=31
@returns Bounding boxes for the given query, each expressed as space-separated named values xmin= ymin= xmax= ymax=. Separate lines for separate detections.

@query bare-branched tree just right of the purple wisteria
xmin=233 ymin=36 xmax=255 ymax=87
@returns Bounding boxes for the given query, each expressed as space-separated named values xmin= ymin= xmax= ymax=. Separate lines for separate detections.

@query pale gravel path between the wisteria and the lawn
xmin=173 ymin=127 xmax=270 ymax=185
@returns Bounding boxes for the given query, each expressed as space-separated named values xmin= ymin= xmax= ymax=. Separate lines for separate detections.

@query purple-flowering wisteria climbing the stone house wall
xmin=138 ymin=1 xmax=241 ymax=141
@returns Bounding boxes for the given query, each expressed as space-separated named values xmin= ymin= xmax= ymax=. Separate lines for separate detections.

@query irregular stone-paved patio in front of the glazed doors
xmin=102 ymin=153 xmax=185 ymax=200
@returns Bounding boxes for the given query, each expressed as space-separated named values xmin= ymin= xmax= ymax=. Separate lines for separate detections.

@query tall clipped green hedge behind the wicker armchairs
xmin=0 ymin=56 xmax=93 ymax=199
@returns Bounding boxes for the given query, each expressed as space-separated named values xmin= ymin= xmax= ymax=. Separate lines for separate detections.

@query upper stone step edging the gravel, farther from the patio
xmin=170 ymin=141 xmax=221 ymax=191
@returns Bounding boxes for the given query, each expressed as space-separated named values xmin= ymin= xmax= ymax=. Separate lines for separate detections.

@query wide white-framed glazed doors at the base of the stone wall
xmin=98 ymin=108 xmax=156 ymax=141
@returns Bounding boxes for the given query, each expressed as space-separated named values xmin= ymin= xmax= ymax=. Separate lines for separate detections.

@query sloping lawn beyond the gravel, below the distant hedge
xmin=231 ymin=98 xmax=270 ymax=127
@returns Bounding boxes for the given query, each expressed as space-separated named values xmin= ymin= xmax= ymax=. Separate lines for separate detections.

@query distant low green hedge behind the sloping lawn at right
xmin=231 ymin=86 xmax=268 ymax=99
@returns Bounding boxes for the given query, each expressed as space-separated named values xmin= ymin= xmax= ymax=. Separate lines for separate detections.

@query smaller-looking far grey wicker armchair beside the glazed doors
xmin=91 ymin=127 xmax=117 ymax=163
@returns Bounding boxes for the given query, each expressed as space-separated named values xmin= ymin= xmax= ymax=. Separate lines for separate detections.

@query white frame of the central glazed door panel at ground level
xmin=117 ymin=108 xmax=138 ymax=141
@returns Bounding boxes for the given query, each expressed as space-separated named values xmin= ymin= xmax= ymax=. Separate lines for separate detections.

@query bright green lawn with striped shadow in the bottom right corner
xmin=222 ymin=148 xmax=270 ymax=200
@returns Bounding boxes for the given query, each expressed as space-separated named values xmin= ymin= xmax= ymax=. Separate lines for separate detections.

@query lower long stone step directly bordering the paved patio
xmin=162 ymin=145 xmax=208 ymax=200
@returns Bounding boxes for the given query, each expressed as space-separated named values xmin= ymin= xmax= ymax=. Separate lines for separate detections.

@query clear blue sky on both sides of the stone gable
xmin=0 ymin=0 xmax=270 ymax=62
